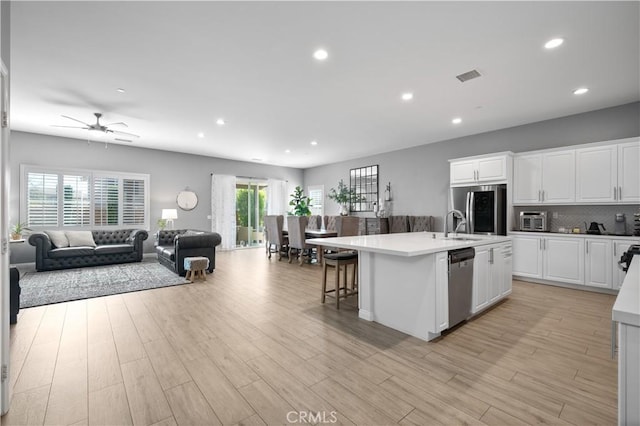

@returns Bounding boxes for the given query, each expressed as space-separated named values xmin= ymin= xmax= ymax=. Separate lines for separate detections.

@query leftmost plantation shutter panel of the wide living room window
xmin=27 ymin=172 xmax=58 ymax=226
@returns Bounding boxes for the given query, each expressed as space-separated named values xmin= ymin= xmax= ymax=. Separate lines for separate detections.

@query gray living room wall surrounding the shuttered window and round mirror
xmin=9 ymin=131 xmax=303 ymax=263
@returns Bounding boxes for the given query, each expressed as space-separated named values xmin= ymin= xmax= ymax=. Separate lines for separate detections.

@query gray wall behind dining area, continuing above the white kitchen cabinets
xmin=304 ymin=102 xmax=640 ymax=229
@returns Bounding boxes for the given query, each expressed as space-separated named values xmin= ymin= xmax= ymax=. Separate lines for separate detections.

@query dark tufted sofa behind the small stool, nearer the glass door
xmin=155 ymin=229 xmax=222 ymax=277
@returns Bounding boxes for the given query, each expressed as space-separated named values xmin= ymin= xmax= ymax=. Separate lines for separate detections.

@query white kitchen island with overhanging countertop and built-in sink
xmin=307 ymin=232 xmax=511 ymax=340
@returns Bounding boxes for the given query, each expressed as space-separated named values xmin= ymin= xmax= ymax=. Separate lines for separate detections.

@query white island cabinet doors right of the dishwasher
xmin=471 ymin=243 xmax=511 ymax=314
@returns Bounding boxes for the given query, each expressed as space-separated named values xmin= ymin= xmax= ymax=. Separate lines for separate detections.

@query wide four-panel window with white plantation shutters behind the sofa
xmin=20 ymin=165 xmax=149 ymax=229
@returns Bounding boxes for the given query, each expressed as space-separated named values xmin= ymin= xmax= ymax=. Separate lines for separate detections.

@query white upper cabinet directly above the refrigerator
xmin=449 ymin=153 xmax=512 ymax=186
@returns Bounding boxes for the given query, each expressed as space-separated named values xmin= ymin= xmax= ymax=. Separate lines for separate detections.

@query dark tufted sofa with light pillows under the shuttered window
xmin=29 ymin=229 xmax=149 ymax=271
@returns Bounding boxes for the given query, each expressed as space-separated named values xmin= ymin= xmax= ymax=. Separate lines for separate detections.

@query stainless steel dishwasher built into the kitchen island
xmin=449 ymin=247 xmax=476 ymax=328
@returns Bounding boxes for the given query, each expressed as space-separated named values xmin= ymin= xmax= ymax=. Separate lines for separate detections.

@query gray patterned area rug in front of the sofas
xmin=20 ymin=262 xmax=189 ymax=308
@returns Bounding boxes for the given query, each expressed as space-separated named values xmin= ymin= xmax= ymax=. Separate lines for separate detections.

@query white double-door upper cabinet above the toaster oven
xmin=513 ymin=150 xmax=575 ymax=204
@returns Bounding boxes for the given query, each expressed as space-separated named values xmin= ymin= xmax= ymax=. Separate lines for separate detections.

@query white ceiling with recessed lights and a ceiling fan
xmin=10 ymin=1 xmax=640 ymax=168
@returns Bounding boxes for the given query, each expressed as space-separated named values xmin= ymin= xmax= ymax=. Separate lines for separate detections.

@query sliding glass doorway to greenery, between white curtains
xmin=236 ymin=177 xmax=267 ymax=248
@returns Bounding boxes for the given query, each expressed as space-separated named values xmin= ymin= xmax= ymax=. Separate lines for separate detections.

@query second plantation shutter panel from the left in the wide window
xmin=62 ymin=175 xmax=91 ymax=226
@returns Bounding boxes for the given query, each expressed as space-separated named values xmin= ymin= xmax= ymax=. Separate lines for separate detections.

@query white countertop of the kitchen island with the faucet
xmin=306 ymin=232 xmax=511 ymax=256
